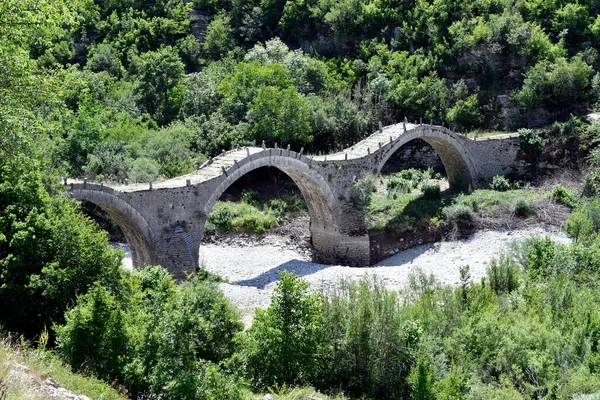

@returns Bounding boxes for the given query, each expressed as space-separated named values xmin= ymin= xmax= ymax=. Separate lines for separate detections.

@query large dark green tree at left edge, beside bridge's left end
xmin=0 ymin=170 xmax=122 ymax=335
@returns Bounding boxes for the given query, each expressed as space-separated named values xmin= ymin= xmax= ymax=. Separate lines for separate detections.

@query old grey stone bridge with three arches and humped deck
xmin=70 ymin=122 xmax=518 ymax=278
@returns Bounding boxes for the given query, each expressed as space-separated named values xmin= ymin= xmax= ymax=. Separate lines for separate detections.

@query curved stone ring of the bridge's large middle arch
xmin=202 ymin=154 xmax=340 ymax=251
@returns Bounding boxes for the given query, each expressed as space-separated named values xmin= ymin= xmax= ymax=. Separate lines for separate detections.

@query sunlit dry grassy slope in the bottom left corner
xmin=0 ymin=337 xmax=127 ymax=400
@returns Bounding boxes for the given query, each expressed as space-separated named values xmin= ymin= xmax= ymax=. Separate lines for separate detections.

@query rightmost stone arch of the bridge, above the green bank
xmin=377 ymin=126 xmax=477 ymax=190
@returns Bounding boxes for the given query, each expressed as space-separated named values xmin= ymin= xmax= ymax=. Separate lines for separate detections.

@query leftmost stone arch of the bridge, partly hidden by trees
xmin=71 ymin=184 xmax=156 ymax=266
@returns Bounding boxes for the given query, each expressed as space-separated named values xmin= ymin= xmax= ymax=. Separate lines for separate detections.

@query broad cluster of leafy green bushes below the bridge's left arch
xmin=55 ymin=267 xmax=242 ymax=399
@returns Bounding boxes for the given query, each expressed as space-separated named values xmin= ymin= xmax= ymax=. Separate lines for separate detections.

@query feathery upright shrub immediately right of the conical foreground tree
xmin=320 ymin=277 xmax=418 ymax=399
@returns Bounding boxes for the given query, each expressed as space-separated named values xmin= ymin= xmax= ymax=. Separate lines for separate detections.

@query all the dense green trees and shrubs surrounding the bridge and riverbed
xmin=0 ymin=0 xmax=600 ymax=400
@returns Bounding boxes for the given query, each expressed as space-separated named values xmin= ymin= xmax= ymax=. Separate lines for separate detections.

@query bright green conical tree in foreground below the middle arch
xmin=242 ymin=271 xmax=326 ymax=388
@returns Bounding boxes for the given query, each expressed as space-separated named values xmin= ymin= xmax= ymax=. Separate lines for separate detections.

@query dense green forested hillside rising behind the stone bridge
xmin=2 ymin=0 xmax=600 ymax=182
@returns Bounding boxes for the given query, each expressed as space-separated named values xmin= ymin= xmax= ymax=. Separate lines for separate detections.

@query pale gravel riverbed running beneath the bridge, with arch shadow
xmin=116 ymin=227 xmax=569 ymax=322
